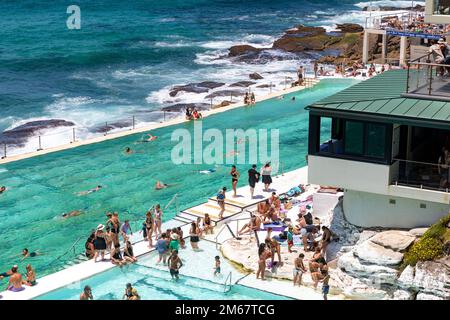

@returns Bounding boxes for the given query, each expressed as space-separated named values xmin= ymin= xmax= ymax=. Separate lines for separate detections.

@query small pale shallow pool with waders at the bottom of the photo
xmin=36 ymin=241 xmax=288 ymax=300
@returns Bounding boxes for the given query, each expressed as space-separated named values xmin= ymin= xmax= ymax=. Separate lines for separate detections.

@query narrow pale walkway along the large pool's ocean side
xmin=0 ymin=79 xmax=320 ymax=165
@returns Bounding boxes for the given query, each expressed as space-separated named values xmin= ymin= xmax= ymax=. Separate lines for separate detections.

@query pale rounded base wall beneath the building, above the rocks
xmin=344 ymin=190 xmax=450 ymax=228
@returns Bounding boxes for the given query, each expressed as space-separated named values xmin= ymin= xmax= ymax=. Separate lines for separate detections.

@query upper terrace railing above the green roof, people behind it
xmin=406 ymin=54 xmax=450 ymax=101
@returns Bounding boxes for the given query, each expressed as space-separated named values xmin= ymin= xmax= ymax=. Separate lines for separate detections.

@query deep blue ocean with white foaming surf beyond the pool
xmin=0 ymin=0 xmax=418 ymax=154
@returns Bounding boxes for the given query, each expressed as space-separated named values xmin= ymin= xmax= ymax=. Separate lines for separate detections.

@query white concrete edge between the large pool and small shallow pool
xmin=0 ymin=166 xmax=308 ymax=301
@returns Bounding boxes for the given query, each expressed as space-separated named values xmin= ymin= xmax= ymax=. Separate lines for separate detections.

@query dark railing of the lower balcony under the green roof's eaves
xmin=392 ymin=159 xmax=450 ymax=193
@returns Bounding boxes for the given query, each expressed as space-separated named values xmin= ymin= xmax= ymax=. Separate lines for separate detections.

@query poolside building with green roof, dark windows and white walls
xmin=307 ymin=68 xmax=450 ymax=228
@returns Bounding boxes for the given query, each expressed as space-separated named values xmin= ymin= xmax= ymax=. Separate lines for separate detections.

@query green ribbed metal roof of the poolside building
xmin=308 ymin=70 xmax=450 ymax=127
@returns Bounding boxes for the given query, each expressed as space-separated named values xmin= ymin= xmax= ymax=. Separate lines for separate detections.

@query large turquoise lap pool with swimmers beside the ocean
xmin=0 ymin=80 xmax=354 ymax=276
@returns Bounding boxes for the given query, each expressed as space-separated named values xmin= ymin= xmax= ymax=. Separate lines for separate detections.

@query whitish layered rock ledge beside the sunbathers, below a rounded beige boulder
xmin=337 ymin=252 xmax=397 ymax=284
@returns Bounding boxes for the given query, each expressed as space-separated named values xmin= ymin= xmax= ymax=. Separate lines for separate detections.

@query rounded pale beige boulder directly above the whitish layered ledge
xmin=354 ymin=240 xmax=403 ymax=266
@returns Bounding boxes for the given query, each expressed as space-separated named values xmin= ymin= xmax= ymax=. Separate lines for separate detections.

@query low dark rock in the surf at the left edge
xmin=0 ymin=119 xmax=75 ymax=146
